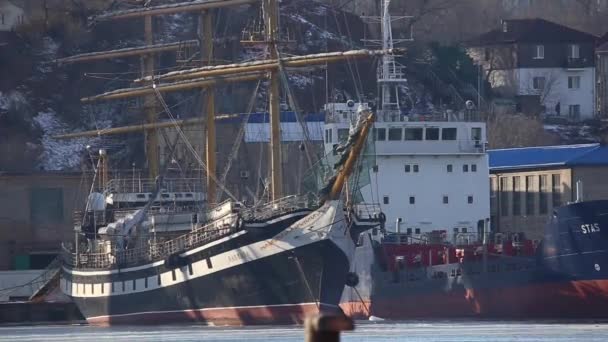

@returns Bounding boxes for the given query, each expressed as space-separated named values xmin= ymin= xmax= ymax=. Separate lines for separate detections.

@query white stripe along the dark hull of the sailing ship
xmin=61 ymin=201 xmax=349 ymax=297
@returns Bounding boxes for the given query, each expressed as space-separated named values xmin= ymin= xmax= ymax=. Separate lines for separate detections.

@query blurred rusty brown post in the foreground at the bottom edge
xmin=304 ymin=315 xmax=355 ymax=342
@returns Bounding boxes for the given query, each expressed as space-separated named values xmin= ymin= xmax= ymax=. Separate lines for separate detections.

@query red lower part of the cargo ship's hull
xmin=340 ymin=280 xmax=608 ymax=319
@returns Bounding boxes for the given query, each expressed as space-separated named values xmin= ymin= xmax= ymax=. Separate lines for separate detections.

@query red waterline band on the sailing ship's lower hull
xmin=87 ymin=303 xmax=342 ymax=326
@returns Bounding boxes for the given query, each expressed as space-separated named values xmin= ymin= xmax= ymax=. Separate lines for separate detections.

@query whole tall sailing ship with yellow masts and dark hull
xmin=55 ymin=0 xmax=385 ymax=325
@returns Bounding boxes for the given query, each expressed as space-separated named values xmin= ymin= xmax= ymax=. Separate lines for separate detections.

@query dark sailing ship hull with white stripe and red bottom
xmin=61 ymin=200 xmax=352 ymax=325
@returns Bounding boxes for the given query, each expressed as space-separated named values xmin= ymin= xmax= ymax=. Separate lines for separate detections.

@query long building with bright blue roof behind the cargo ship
xmin=488 ymin=144 xmax=608 ymax=239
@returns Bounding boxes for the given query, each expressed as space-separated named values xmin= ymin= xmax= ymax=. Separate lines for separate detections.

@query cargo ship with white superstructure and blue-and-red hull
xmin=325 ymin=0 xmax=608 ymax=320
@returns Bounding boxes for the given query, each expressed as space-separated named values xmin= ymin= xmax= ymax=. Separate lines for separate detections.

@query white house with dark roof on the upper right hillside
xmin=469 ymin=19 xmax=597 ymax=121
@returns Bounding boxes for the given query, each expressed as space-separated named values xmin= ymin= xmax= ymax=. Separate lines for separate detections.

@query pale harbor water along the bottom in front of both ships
xmin=0 ymin=321 xmax=608 ymax=342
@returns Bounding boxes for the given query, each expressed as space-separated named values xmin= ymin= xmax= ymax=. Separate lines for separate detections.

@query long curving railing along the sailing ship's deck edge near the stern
xmin=63 ymin=214 xmax=237 ymax=269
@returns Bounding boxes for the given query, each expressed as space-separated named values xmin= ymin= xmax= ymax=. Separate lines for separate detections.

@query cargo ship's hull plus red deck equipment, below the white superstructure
xmin=341 ymin=201 xmax=608 ymax=320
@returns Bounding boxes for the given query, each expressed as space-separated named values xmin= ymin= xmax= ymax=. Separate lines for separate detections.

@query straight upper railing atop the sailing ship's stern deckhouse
xmin=106 ymin=178 xmax=203 ymax=193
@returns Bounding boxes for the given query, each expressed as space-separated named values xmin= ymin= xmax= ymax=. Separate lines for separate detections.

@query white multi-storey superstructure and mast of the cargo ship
xmin=324 ymin=0 xmax=490 ymax=240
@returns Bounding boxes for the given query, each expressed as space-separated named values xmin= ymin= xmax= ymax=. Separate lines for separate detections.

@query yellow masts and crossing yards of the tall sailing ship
xmin=58 ymin=0 xmax=392 ymax=201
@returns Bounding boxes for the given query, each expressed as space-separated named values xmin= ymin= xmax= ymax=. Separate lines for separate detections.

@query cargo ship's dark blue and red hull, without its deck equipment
xmin=341 ymin=201 xmax=608 ymax=319
